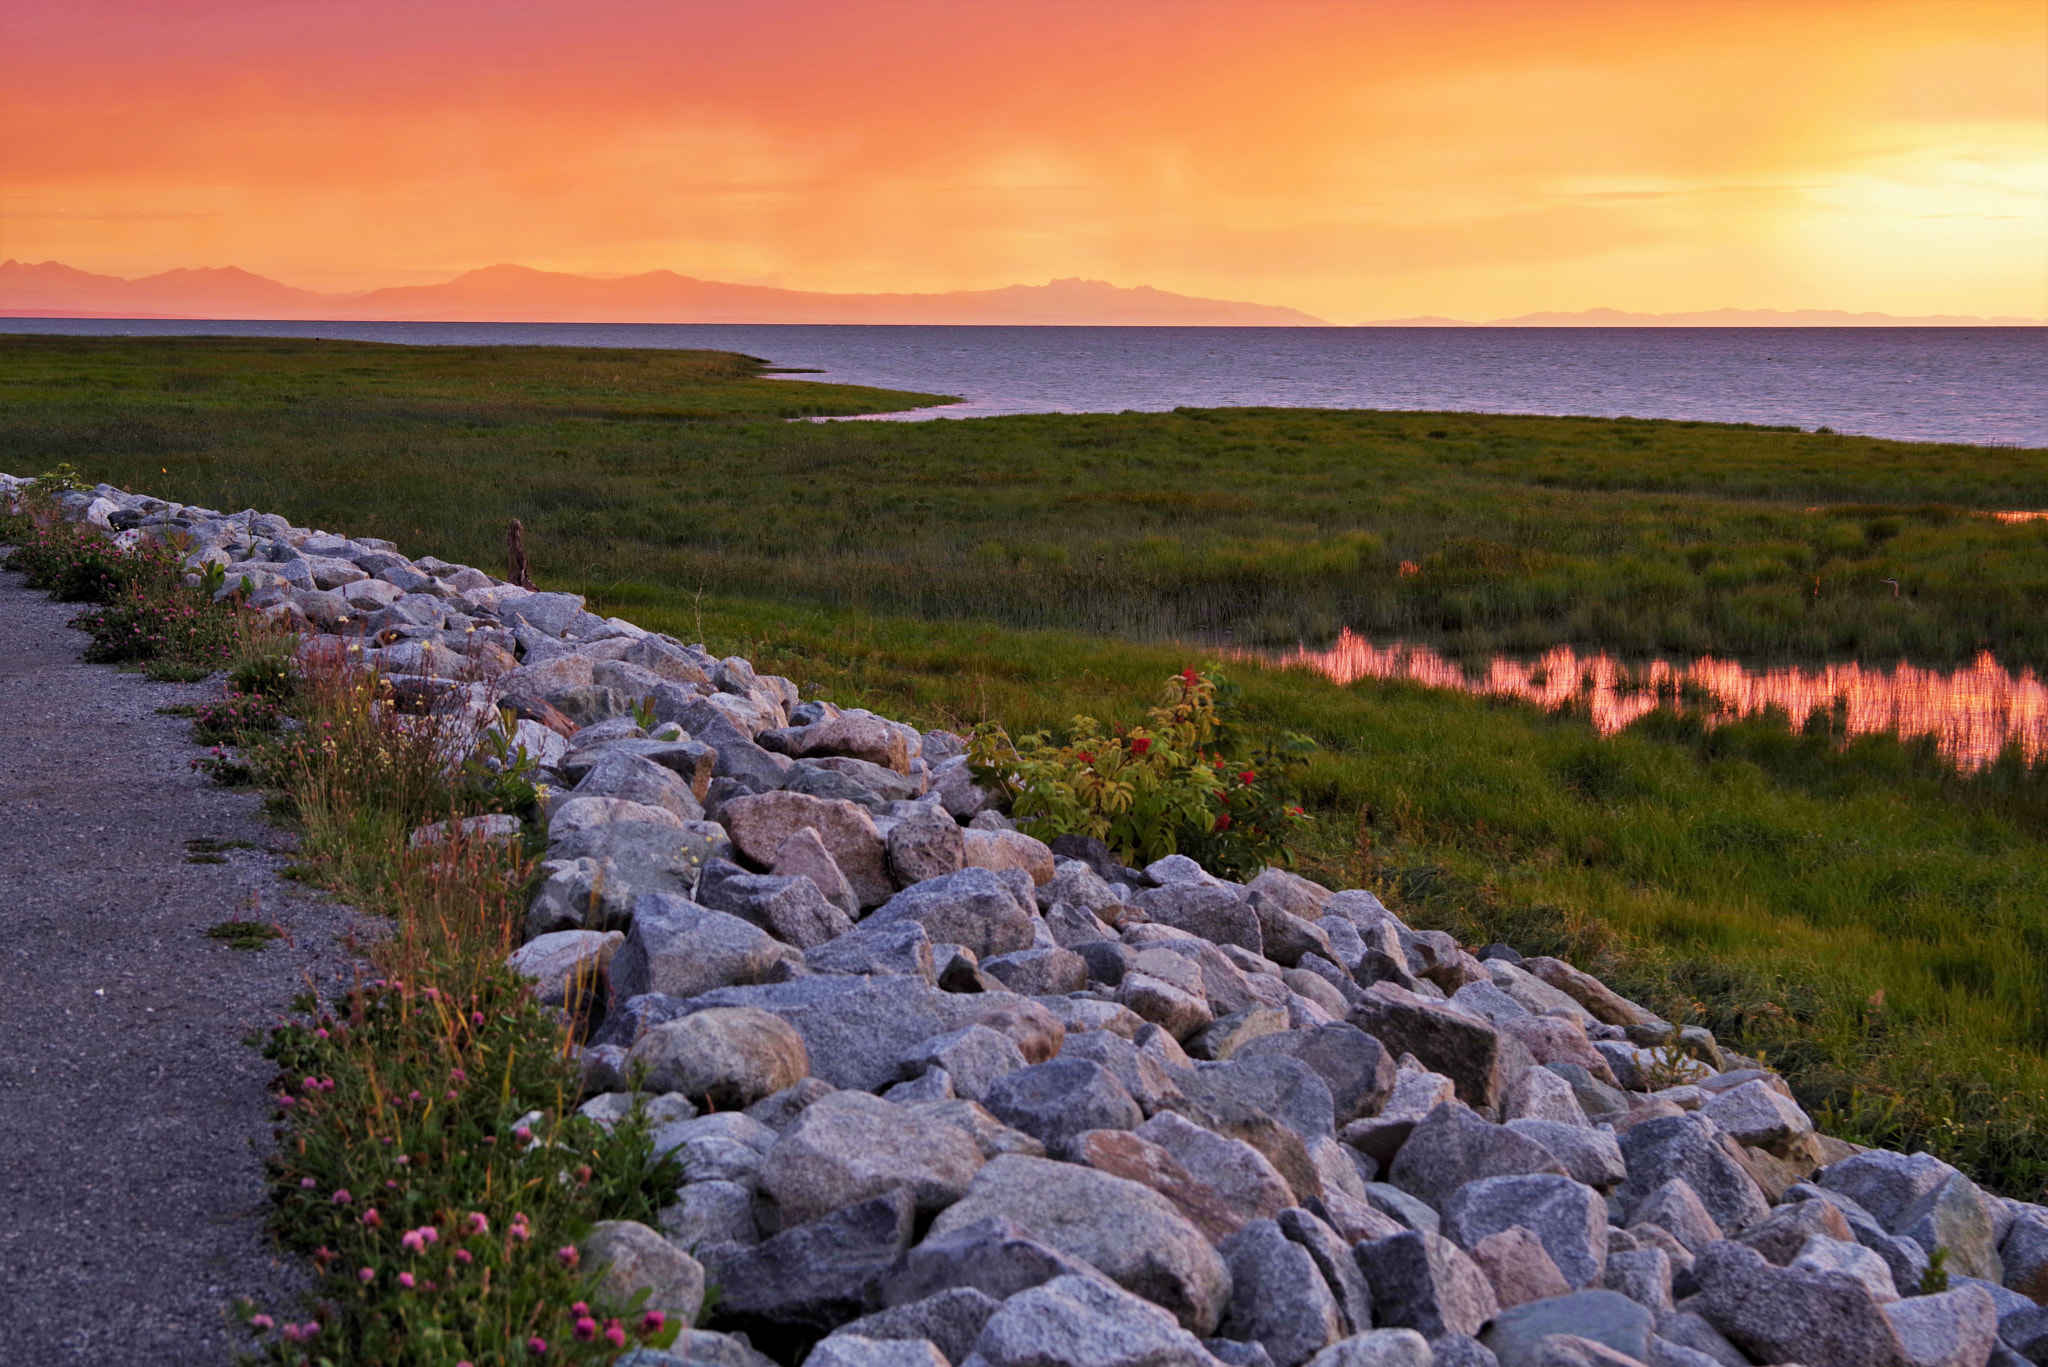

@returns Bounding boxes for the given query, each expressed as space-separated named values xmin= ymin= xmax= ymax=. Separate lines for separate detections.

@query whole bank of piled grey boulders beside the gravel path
xmin=16 ymin=478 xmax=2048 ymax=1367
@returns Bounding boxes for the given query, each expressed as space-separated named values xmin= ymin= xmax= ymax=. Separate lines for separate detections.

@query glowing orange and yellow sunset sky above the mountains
xmin=0 ymin=0 xmax=2048 ymax=322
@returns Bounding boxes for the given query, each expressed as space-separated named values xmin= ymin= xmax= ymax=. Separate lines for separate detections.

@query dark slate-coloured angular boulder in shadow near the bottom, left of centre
xmin=702 ymin=1189 xmax=918 ymax=1361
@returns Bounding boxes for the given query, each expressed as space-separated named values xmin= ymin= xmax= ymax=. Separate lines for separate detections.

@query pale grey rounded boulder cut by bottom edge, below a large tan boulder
xmin=963 ymin=1277 xmax=1217 ymax=1367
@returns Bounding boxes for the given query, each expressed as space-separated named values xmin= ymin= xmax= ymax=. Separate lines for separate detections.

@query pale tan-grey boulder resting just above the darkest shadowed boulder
xmin=760 ymin=1092 xmax=983 ymax=1228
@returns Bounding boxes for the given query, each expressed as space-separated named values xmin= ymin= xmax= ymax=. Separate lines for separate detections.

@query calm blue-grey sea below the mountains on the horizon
xmin=0 ymin=318 xmax=2048 ymax=447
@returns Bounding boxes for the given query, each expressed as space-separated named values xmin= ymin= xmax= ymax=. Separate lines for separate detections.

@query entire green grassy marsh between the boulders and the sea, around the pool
xmin=0 ymin=338 xmax=2048 ymax=1195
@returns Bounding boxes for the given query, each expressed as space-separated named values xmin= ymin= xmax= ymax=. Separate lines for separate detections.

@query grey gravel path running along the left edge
xmin=0 ymin=574 xmax=354 ymax=1367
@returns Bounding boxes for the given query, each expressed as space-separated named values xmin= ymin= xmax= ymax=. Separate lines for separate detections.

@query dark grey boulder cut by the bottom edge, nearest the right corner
xmin=1688 ymin=1240 xmax=1905 ymax=1367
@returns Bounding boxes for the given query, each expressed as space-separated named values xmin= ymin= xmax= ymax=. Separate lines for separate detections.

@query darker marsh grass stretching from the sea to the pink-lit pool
xmin=0 ymin=336 xmax=2048 ymax=666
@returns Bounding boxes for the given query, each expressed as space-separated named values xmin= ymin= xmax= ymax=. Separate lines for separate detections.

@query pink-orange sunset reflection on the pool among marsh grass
xmin=1264 ymin=629 xmax=2048 ymax=769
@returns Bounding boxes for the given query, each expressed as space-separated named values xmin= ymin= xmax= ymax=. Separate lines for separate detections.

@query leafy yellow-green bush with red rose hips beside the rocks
xmin=969 ymin=668 xmax=1315 ymax=875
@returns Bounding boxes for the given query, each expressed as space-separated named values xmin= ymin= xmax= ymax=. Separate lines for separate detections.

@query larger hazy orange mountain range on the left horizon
xmin=0 ymin=260 xmax=1329 ymax=328
